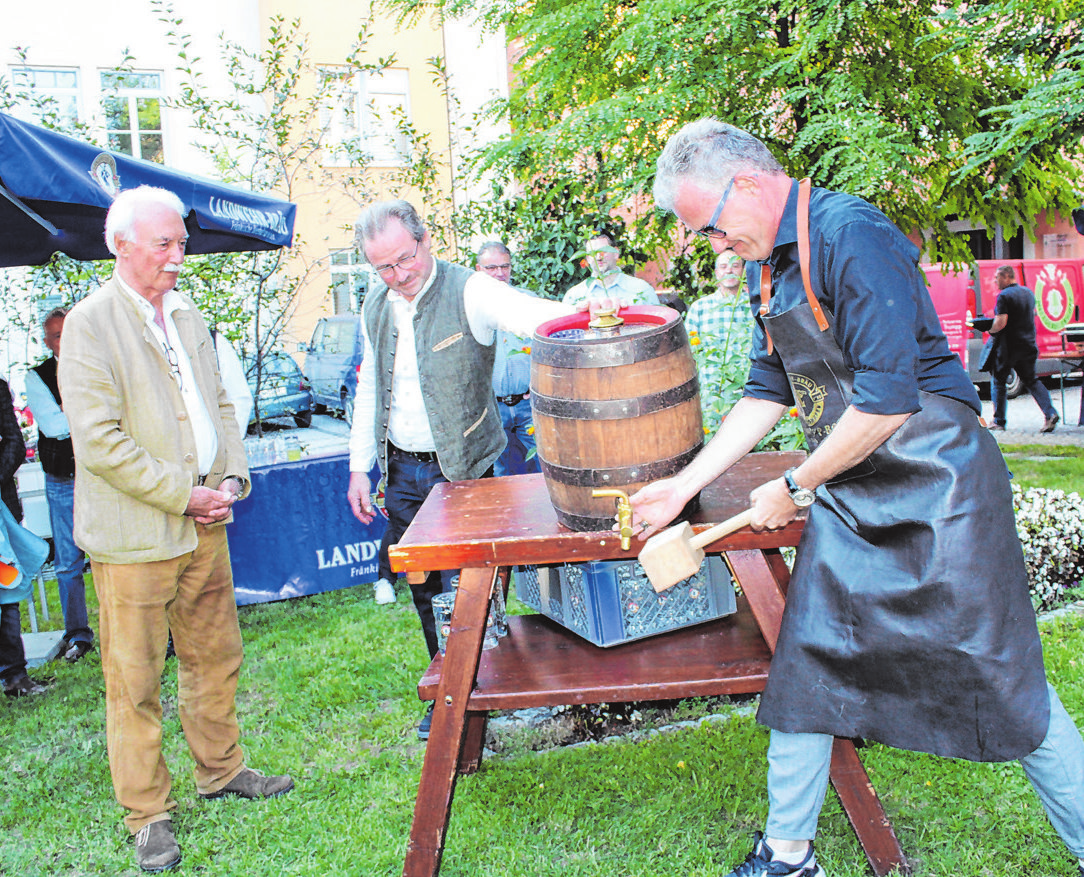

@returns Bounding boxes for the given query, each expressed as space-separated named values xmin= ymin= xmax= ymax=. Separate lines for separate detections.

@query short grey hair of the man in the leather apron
xmin=654 ymin=116 xmax=784 ymax=211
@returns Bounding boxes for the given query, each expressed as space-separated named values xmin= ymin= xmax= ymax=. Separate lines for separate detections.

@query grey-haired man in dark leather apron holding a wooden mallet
xmin=632 ymin=119 xmax=1084 ymax=877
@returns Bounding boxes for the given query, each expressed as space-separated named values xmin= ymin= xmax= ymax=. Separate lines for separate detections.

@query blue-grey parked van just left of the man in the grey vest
xmin=298 ymin=313 xmax=363 ymax=423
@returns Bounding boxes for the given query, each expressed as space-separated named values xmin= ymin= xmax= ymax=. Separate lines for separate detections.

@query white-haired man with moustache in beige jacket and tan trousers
xmin=60 ymin=186 xmax=294 ymax=872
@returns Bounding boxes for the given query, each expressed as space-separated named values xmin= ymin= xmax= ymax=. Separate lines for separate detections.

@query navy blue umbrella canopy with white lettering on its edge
xmin=0 ymin=113 xmax=296 ymax=268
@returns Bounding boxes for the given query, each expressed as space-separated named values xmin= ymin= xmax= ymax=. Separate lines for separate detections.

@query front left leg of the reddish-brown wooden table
xmin=403 ymin=569 xmax=496 ymax=877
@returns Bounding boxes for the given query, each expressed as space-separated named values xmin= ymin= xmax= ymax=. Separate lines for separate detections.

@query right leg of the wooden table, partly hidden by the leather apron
xmin=725 ymin=551 xmax=911 ymax=877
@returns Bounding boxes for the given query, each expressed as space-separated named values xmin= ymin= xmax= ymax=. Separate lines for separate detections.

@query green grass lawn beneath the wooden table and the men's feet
xmin=6 ymin=447 xmax=1084 ymax=877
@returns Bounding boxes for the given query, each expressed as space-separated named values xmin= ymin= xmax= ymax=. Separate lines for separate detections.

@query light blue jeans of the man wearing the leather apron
xmin=765 ymin=684 xmax=1084 ymax=859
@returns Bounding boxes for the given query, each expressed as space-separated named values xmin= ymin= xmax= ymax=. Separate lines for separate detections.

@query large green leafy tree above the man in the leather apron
xmin=389 ymin=0 xmax=1079 ymax=292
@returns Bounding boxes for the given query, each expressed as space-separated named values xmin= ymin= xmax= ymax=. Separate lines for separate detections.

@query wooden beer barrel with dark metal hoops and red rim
xmin=530 ymin=306 xmax=704 ymax=530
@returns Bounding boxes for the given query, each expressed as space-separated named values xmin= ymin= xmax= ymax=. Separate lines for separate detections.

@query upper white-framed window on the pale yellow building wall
xmin=320 ymin=67 xmax=412 ymax=168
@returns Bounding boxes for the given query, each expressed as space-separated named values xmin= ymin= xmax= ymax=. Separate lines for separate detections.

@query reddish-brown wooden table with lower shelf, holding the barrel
xmin=390 ymin=452 xmax=909 ymax=877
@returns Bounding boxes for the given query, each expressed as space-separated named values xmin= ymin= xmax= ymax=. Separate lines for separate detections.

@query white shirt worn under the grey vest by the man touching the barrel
xmin=350 ymin=260 xmax=576 ymax=474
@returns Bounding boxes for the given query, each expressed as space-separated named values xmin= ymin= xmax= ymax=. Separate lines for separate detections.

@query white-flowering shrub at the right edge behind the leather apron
xmin=1012 ymin=485 xmax=1084 ymax=610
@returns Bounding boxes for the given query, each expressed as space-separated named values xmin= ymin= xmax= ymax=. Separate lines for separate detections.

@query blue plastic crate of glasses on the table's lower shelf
xmin=515 ymin=556 xmax=736 ymax=646
